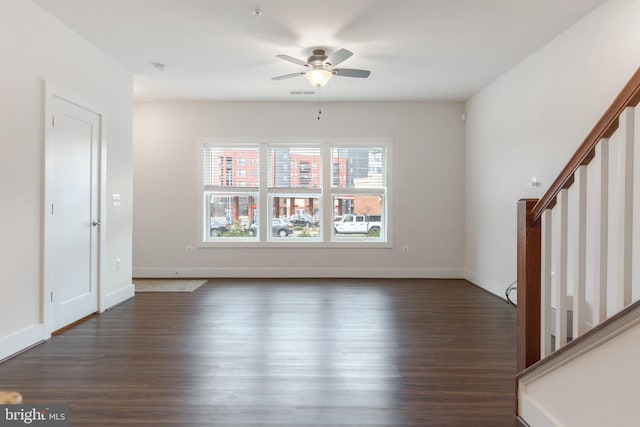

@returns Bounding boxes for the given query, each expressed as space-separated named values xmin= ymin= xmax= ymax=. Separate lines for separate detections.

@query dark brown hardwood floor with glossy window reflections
xmin=0 ymin=279 xmax=517 ymax=427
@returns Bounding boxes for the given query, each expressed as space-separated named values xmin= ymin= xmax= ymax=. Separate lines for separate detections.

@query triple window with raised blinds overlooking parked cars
xmin=202 ymin=140 xmax=391 ymax=246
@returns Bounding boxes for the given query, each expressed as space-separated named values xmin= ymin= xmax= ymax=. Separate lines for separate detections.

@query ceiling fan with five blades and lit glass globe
xmin=272 ymin=49 xmax=371 ymax=87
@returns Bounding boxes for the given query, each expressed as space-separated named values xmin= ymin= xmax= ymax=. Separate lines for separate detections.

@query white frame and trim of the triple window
xmin=197 ymin=137 xmax=394 ymax=249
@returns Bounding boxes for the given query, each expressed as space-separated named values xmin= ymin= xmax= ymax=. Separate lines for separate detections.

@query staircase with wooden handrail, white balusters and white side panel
xmin=516 ymin=69 xmax=640 ymax=427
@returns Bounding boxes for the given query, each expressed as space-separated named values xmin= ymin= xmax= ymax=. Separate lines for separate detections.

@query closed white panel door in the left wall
xmin=45 ymin=96 xmax=101 ymax=331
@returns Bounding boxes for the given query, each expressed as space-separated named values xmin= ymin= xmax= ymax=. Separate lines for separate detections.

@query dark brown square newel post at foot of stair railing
xmin=517 ymin=199 xmax=542 ymax=372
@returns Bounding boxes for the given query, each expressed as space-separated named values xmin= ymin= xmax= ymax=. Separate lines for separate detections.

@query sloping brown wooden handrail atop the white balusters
xmin=531 ymin=68 xmax=640 ymax=222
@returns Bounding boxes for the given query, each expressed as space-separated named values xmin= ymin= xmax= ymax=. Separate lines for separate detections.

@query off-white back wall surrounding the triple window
xmin=133 ymin=102 xmax=464 ymax=277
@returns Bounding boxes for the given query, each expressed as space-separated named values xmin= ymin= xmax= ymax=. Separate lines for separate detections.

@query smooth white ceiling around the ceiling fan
xmin=33 ymin=0 xmax=605 ymax=101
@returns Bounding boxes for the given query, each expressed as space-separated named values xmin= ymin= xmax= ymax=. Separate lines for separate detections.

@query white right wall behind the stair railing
xmin=465 ymin=0 xmax=640 ymax=295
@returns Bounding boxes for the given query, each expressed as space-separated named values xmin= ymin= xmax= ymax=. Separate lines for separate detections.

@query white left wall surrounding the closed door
xmin=0 ymin=0 xmax=133 ymax=359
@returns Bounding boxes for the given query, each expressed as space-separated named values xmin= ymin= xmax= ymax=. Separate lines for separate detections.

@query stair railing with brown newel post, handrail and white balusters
xmin=517 ymin=68 xmax=640 ymax=372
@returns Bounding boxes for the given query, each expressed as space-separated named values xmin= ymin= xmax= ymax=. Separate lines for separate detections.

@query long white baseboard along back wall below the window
xmin=133 ymin=267 xmax=464 ymax=279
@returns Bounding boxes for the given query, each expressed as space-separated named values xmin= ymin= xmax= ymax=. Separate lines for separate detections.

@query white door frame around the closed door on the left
xmin=40 ymin=81 xmax=107 ymax=339
